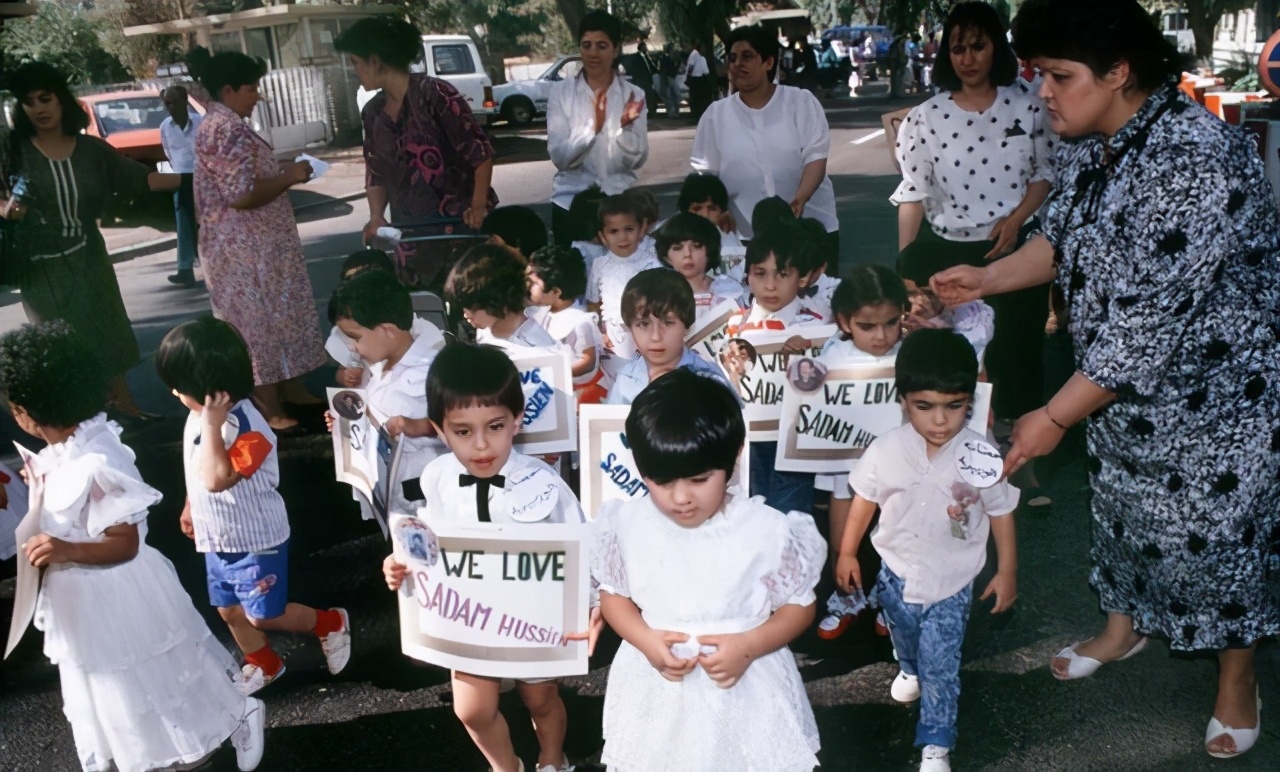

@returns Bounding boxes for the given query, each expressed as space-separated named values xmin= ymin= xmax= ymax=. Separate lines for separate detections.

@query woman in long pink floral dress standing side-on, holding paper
xmin=187 ymin=49 xmax=325 ymax=431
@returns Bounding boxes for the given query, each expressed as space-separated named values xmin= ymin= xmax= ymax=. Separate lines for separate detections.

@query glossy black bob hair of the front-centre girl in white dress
xmin=626 ymin=367 xmax=746 ymax=484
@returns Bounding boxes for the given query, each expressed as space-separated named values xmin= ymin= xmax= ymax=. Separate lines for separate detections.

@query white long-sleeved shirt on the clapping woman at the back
xmin=547 ymin=74 xmax=649 ymax=209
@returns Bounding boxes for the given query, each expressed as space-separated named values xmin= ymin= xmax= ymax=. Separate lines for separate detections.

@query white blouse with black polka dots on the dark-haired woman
xmin=890 ymin=81 xmax=1059 ymax=242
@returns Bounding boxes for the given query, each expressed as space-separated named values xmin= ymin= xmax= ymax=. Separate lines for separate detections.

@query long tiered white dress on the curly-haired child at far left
xmin=32 ymin=415 xmax=246 ymax=772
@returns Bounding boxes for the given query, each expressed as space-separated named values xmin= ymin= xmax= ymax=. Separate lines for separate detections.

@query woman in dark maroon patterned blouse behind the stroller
xmin=334 ymin=17 xmax=498 ymax=280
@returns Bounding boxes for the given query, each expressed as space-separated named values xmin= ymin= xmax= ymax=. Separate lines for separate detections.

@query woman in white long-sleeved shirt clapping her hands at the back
xmin=547 ymin=10 xmax=649 ymax=247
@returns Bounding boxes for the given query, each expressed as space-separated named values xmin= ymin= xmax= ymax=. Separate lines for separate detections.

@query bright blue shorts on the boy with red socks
xmin=205 ymin=539 xmax=289 ymax=620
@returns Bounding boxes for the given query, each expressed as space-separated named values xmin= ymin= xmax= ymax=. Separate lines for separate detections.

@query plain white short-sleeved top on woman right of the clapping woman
xmin=690 ymin=86 xmax=840 ymax=238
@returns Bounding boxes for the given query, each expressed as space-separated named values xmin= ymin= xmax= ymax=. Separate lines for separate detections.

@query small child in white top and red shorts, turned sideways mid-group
xmin=529 ymin=246 xmax=605 ymax=405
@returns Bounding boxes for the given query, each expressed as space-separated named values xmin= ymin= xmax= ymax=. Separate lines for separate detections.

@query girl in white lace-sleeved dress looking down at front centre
xmin=591 ymin=370 xmax=824 ymax=772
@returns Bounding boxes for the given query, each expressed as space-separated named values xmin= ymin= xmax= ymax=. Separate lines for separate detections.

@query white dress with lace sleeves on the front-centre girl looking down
xmin=591 ymin=497 xmax=827 ymax=772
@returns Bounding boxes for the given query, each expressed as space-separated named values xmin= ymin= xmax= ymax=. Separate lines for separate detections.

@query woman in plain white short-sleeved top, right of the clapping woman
xmin=692 ymin=26 xmax=840 ymax=266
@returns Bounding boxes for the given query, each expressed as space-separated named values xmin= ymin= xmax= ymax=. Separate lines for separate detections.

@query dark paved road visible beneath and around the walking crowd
xmin=0 ymin=104 xmax=1280 ymax=771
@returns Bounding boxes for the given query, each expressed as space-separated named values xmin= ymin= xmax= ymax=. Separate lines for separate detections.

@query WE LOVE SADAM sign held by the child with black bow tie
xmin=390 ymin=515 xmax=590 ymax=679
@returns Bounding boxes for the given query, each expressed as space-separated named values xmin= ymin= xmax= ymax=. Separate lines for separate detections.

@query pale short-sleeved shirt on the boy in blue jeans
xmin=849 ymin=424 xmax=1018 ymax=603
